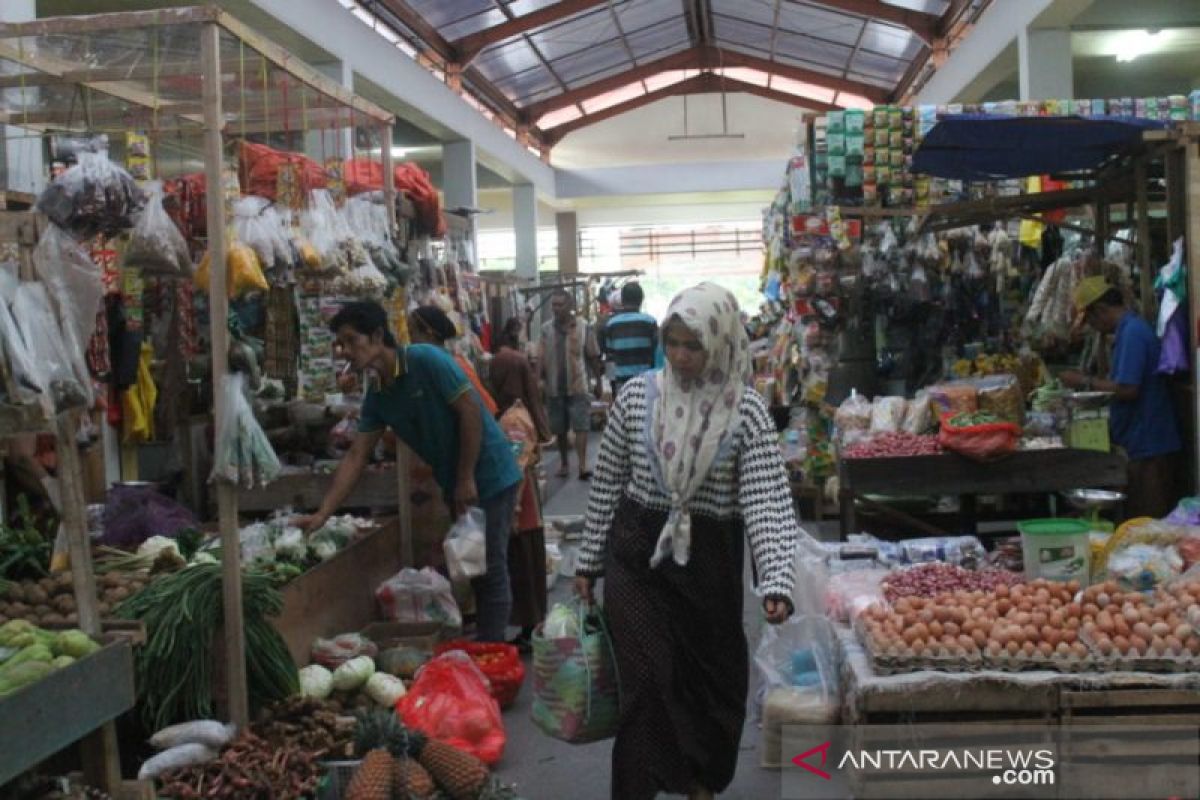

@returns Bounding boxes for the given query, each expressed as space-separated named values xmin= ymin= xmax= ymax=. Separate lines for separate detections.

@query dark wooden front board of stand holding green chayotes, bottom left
xmin=0 ymin=640 xmax=134 ymax=786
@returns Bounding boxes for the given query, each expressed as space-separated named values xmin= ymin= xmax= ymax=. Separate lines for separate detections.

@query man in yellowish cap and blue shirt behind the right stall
xmin=1061 ymin=276 xmax=1183 ymax=518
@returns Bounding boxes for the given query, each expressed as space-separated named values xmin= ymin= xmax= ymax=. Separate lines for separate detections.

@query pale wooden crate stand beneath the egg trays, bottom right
xmin=838 ymin=625 xmax=1200 ymax=798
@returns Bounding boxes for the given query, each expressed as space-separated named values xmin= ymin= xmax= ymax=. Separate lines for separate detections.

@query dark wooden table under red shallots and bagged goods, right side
xmin=838 ymin=447 xmax=1128 ymax=539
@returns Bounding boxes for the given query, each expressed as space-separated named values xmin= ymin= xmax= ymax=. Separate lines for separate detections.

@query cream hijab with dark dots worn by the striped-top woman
xmin=650 ymin=283 xmax=751 ymax=567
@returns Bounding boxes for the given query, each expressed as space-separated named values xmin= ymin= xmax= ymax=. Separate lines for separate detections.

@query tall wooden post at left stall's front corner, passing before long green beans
xmin=200 ymin=24 xmax=250 ymax=728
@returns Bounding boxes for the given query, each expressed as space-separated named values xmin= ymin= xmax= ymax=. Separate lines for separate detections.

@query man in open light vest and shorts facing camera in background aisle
xmin=539 ymin=289 xmax=600 ymax=481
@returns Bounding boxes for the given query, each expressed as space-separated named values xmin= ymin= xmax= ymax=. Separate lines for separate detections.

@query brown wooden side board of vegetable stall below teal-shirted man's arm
xmin=274 ymin=520 xmax=402 ymax=664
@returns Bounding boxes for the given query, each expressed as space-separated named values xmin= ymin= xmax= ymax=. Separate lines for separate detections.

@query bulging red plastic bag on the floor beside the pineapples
xmin=396 ymin=650 xmax=508 ymax=765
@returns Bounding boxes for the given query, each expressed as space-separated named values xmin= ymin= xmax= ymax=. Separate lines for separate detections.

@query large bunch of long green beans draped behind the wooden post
xmin=116 ymin=564 xmax=300 ymax=730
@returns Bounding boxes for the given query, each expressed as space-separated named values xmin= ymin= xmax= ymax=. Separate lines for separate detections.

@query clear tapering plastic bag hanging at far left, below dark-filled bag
xmin=34 ymin=225 xmax=104 ymax=405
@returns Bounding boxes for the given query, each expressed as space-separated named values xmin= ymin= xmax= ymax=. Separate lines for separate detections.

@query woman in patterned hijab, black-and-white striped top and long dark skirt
xmin=576 ymin=283 xmax=799 ymax=800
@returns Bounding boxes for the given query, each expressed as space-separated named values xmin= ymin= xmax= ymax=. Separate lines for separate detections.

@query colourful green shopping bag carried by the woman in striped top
xmin=532 ymin=600 xmax=620 ymax=745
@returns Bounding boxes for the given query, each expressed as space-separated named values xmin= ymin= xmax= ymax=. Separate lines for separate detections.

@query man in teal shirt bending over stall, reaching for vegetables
xmin=306 ymin=302 xmax=521 ymax=642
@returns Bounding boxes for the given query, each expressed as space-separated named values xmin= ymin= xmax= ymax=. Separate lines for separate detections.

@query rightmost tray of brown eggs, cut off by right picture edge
xmin=1081 ymin=581 xmax=1200 ymax=658
